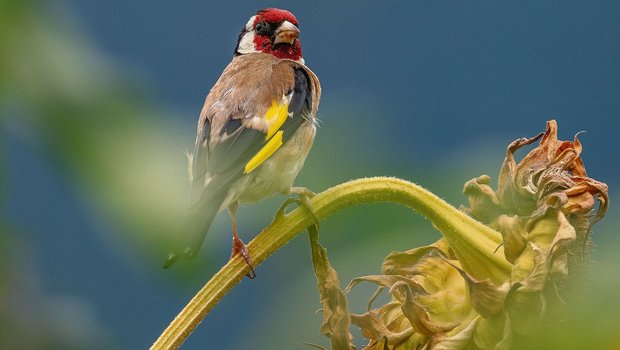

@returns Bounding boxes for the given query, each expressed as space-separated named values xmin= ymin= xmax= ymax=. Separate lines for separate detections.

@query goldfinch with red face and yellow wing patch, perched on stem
xmin=164 ymin=8 xmax=321 ymax=278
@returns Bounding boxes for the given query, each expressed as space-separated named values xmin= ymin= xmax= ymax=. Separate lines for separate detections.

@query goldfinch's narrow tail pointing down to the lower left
xmin=164 ymin=191 xmax=226 ymax=268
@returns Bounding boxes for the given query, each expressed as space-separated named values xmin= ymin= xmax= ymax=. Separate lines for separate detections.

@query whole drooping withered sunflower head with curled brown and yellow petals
xmin=317 ymin=120 xmax=609 ymax=350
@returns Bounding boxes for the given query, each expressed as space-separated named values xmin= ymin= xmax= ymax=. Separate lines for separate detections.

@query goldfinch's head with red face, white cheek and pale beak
xmin=235 ymin=8 xmax=304 ymax=63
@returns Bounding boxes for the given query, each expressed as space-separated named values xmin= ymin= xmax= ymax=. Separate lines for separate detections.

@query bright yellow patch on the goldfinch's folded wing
xmin=243 ymin=96 xmax=288 ymax=174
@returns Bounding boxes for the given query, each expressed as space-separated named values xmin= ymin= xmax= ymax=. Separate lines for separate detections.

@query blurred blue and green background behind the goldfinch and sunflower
xmin=0 ymin=0 xmax=620 ymax=349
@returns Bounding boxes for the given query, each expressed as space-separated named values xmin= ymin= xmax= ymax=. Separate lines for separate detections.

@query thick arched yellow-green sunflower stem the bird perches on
xmin=151 ymin=177 xmax=511 ymax=349
